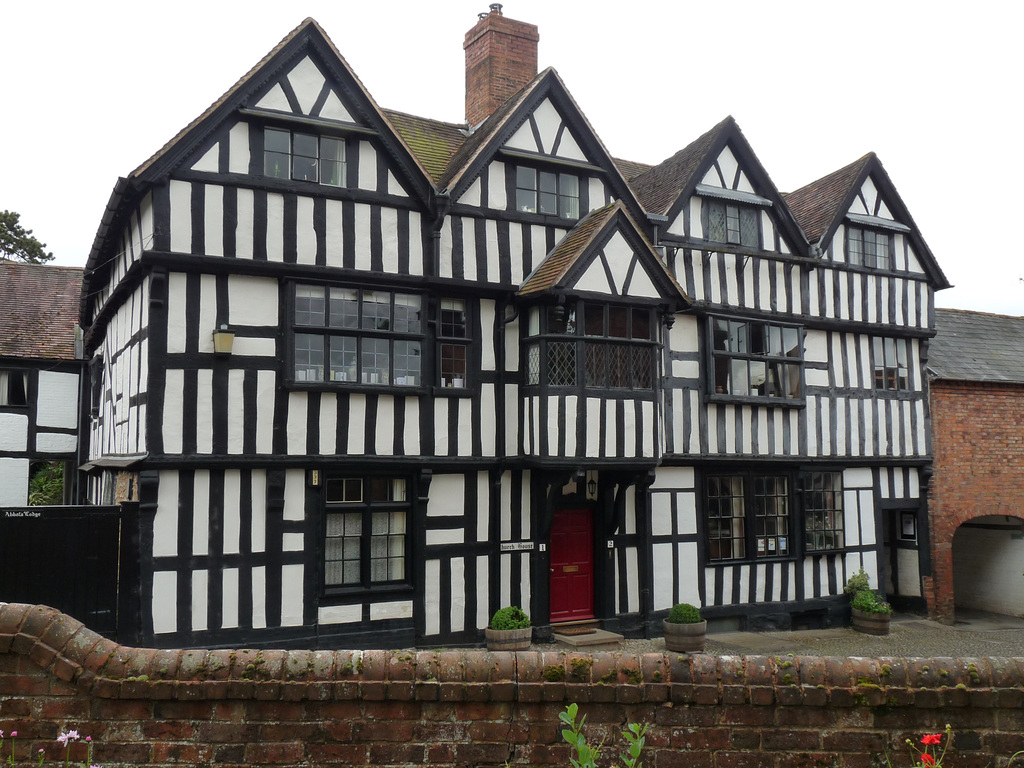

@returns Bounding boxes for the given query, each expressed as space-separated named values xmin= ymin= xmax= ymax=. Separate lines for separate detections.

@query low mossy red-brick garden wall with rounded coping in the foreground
xmin=0 ymin=603 xmax=1024 ymax=768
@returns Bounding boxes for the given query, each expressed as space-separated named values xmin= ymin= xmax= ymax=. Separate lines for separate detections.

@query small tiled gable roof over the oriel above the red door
xmin=519 ymin=201 xmax=688 ymax=304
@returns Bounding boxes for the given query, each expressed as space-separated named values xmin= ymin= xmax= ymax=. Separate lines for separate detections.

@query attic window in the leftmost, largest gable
xmin=263 ymin=128 xmax=345 ymax=186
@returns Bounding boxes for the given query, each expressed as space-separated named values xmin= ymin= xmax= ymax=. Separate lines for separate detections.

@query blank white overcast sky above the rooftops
xmin=0 ymin=0 xmax=1024 ymax=314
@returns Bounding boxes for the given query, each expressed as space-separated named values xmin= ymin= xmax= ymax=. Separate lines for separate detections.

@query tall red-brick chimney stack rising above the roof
xmin=462 ymin=3 xmax=541 ymax=126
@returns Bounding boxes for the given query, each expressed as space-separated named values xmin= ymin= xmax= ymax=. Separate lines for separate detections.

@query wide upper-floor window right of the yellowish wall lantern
xmin=293 ymin=284 xmax=423 ymax=387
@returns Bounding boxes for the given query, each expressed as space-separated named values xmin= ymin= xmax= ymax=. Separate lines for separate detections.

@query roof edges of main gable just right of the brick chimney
xmin=437 ymin=67 xmax=644 ymax=225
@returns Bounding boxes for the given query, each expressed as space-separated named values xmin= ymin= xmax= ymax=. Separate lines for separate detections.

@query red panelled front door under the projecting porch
xmin=551 ymin=509 xmax=594 ymax=624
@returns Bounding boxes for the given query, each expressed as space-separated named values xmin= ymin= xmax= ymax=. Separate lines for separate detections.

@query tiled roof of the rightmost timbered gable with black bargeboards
xmin=783 ymin=152 xmax=949 ymax=290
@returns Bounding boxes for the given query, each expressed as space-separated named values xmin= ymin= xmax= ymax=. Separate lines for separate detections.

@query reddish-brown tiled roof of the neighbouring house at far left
xmin=0 ymin=259 xmax=83 ymax=359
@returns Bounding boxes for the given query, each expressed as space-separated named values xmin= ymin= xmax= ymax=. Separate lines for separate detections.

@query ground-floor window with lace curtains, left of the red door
xmin=324 ymin=477 xmax=410 ymax=588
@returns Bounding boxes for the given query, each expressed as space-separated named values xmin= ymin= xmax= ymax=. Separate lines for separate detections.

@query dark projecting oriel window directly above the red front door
xmin=522 ymin=298 xmax=660 ymax=397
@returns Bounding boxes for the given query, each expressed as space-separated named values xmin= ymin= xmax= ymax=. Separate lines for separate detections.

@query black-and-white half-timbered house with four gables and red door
xmin=83 ymin=6 xmax=946 ymax=647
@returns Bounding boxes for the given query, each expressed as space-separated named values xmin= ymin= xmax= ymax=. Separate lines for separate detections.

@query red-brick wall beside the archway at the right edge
xmin=925 ymin=380 xmax=1024 ymax=624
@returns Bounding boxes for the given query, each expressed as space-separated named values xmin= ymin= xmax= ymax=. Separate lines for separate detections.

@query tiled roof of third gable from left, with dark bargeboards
xmin=630 ymin=115 xmax=807 ymax=257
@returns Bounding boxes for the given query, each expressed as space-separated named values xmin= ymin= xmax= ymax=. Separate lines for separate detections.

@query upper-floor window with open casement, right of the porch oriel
xmin=711 ymin=317 xmax=804 ymax=400
